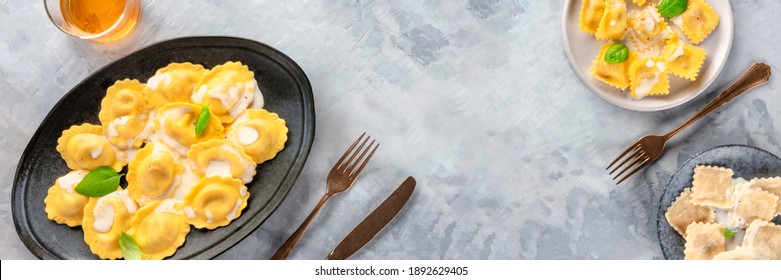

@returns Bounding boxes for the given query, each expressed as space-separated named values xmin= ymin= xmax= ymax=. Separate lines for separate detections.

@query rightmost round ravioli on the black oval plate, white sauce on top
xmin=228 ymin=109 xmax=288 ymax=164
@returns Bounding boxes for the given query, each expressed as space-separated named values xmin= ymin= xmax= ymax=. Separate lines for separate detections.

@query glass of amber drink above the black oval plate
xmin=43 ymin=0 xmax=141 ymax=43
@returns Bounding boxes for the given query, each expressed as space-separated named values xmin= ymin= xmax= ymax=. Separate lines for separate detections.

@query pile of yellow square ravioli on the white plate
xmin=579 ymin=0 xmax=719 ymax=100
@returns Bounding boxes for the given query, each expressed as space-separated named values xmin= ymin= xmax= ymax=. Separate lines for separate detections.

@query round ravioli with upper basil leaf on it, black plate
xmin=154 ymin=102 xmax=225 ymax=155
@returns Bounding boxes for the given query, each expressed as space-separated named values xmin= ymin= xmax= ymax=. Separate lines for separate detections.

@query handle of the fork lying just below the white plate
xmin=664 ymin=63 xmax=770 ymax=140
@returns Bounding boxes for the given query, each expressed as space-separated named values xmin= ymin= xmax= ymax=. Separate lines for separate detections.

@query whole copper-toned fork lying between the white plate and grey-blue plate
xmin=607 ymin=63 xmax=770 ymax=185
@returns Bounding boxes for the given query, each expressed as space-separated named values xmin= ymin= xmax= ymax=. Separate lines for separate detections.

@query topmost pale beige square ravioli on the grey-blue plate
xmin=692 ymin=165 xmax=734 ymax=208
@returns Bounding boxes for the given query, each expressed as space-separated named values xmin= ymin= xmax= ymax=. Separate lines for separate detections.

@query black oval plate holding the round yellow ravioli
xmin=11 ymin=37 xmax=315 ymax=259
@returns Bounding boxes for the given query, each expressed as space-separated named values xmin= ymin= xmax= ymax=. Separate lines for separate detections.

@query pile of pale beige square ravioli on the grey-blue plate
xmin=665 ymin=165 xmax=781 ymax=260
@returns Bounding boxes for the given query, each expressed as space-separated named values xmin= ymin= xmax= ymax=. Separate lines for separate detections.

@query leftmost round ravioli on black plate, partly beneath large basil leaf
xmin=43 ymin=170 xmax=89 ymax=227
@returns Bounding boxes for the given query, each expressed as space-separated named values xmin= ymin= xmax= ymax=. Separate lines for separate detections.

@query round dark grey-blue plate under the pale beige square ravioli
xmin=656 ymin=145 xmax=781 ymax=260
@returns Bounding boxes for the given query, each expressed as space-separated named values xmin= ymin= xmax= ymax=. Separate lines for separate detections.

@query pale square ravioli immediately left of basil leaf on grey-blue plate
xmin=683 ymin=223 xmax=727 ymax=260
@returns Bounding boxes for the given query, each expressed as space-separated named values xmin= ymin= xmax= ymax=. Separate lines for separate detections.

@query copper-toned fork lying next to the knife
xmin=271 ymin=132 xmax=380 ymax=260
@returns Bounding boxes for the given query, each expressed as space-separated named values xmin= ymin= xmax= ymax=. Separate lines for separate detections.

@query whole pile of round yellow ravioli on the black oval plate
xmin=44 ymin=62 xmax=288 ymax=259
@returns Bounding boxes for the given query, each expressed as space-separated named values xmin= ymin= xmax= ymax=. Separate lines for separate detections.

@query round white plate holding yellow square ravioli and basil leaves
xmin=562 ymin=0 xmax=734 ymax=111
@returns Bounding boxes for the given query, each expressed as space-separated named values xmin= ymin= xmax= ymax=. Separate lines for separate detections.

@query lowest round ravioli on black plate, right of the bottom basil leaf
xmin=127 ymin=199 xmax=190 ymax=260
